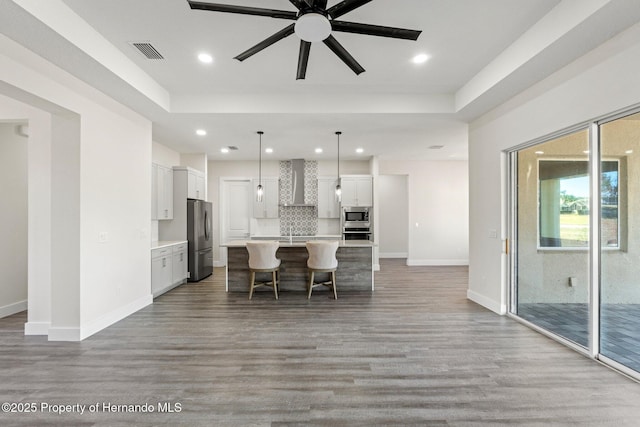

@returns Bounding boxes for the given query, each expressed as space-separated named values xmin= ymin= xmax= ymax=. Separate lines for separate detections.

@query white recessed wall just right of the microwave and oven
xmin=376 ymin=175 xmax=409 ymax=258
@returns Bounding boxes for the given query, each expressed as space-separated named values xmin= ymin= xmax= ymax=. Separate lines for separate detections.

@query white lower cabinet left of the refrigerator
xmin=151 ymin=242 xmax=189 ymax=298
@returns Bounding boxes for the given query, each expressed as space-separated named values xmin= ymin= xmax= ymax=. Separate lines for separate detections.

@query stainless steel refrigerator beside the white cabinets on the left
xmin=187 ymin=199 xmax=213 ymax=282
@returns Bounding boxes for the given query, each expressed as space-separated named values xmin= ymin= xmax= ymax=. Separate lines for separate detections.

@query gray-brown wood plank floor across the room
xmin=0 ymin=260 xmax=640 ymax=426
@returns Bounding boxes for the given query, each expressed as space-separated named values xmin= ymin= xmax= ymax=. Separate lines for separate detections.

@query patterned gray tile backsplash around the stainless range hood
xmin=280 ymin=160 xmax=318 ymax=236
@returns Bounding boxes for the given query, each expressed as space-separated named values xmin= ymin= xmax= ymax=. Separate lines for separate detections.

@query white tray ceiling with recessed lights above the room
xmin=0 ymin=0 xmax=640 ymax=160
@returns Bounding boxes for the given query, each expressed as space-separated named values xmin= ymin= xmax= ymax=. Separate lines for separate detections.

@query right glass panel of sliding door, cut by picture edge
xmin=600 ymin=114 xmax=640 ymax=372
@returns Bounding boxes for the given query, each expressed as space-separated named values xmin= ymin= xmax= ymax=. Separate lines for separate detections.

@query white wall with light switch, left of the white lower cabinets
xmin=80 ymin=105 xmax=151 ymax=342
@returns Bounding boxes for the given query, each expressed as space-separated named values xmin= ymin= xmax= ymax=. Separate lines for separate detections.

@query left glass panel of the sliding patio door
xmin=512 ymin=129 xmax=590 ymax=347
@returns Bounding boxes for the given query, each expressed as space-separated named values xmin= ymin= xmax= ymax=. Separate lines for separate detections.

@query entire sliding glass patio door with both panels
xmin=509 ymin=112 xmax=640 ymax=378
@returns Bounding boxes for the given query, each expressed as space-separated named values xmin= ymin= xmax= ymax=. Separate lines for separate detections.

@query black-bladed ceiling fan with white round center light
xmin=187 ymin=0 xmax=422 ymax=80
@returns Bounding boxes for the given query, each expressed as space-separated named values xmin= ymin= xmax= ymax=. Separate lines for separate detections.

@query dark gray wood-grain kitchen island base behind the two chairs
xmin=222 ymin=240 xmax=374 ymax=298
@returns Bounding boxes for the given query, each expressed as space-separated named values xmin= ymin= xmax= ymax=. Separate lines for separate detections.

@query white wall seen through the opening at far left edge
xmin=0 ymin=122 xmax=28 ymax=317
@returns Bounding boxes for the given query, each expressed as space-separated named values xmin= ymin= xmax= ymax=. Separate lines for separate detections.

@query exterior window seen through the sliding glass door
xmin=538 ymin=159 xmax=620 ymax=248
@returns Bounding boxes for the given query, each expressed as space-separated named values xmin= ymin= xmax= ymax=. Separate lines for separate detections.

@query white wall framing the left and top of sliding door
xmin=468 ymin=25 xmax=640 ymax=313
